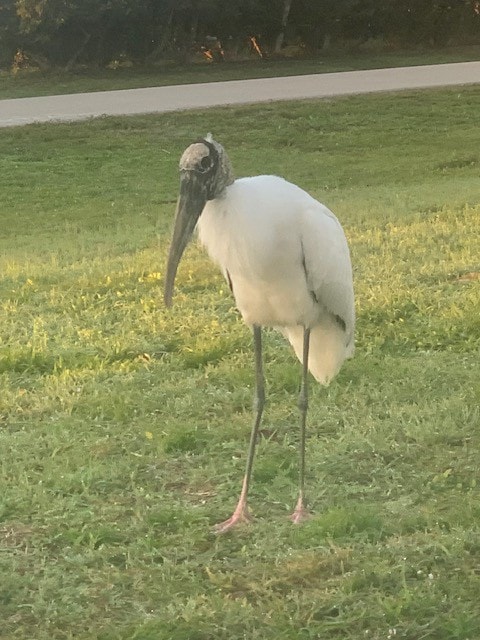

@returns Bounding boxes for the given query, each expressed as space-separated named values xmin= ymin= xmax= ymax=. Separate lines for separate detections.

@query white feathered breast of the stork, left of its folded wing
xmin=198 ymin=184 xmax=318 ymax=326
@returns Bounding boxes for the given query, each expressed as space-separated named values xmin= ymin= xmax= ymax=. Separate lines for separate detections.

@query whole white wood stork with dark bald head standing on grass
xmin=164 ymin=134 xmax=355 ymax=533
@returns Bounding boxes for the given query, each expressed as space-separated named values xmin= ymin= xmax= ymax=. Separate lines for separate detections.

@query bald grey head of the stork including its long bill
xmin=164 ymin=134 xmax=234 ymax=307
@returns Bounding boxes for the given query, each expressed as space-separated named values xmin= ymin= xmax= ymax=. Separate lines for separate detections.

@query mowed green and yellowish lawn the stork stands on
xmin=0 ymin=87 xmax=480 ymax=640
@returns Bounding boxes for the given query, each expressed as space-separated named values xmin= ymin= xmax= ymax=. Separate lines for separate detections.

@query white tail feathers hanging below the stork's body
xmin=281 ymin=320 xmax=353 ymax=385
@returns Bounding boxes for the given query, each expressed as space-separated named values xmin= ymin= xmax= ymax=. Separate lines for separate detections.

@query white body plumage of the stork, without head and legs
xmin=197 ymin=176 xmax=355 ymax=384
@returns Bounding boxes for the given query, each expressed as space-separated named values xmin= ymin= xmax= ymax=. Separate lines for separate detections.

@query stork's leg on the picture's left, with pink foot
xmin=215 ymin=325 xmax=265 ymax=533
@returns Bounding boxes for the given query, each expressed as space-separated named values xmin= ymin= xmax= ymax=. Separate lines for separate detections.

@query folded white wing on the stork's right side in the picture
xmin=301 ymin=205 xmax=355 ymax=344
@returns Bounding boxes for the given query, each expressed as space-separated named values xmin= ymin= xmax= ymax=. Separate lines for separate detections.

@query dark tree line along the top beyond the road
xmin=0 ymin=0 xmax=480 ymax=69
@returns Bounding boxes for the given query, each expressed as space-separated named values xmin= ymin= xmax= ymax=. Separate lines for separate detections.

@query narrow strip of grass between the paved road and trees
xmin=0 ymin=45 xmax=480 ymax=99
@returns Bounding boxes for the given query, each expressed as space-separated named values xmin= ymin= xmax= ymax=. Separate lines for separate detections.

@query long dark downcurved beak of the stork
xmin=163 ymin=171 xmax=207 ymax=307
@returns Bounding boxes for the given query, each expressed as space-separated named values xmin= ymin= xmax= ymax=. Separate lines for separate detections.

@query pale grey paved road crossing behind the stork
xmin=0 ymin=62 xmax=480 ymax=127
